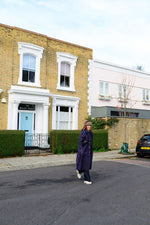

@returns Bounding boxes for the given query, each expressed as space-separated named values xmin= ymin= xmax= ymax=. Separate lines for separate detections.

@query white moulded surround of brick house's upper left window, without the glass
xmin=18 ymin=42 xmax=44 ymax=87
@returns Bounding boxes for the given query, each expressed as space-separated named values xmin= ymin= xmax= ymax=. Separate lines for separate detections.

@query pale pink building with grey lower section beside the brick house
xmin=88 ymin=60 xmax=150 ymax=119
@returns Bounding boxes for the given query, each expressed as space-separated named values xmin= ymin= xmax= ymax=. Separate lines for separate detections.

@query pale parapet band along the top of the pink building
xmin=93 ymin=59 xmax=150 ymax=79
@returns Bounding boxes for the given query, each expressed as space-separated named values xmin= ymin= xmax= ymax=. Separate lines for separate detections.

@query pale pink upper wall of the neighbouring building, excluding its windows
xmin=89 ymin=60 xmax=150 ymax=114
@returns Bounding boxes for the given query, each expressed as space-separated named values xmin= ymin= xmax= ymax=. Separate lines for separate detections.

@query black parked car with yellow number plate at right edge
xmin=136 ymin=134 xmax=150 ymax=157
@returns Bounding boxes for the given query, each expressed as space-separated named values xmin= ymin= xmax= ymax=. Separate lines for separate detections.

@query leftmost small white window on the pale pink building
xmin=99 ymin=81 xmax=111 ymax=100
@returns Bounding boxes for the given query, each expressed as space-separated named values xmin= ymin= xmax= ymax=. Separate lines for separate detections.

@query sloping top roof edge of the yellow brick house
xmin=0 ymin=23 xmax=93 ymax=51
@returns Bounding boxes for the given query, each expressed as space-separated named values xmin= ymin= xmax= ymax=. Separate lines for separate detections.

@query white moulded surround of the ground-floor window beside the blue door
xmin=50 ymin=94 xmax=80 ymax=130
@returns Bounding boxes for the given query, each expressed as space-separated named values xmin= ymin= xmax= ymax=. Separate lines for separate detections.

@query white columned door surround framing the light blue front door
xmin=8 ymin=86 xmax=50 ymax=134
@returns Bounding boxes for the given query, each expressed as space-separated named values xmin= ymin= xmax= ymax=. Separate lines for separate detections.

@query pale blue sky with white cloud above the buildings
xmin=0 ymin=0 xmax=150 ymax=72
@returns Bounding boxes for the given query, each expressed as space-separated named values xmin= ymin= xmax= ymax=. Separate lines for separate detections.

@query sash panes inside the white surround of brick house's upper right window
xmin=60 ymin=62 xmax=70 ymax=87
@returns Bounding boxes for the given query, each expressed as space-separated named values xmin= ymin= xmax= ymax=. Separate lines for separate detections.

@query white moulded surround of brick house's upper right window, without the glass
xmin=56 ymin=52 xmax=77 ymax=92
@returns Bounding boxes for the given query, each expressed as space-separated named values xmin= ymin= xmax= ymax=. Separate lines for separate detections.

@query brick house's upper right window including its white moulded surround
xmin=57 ymin=52 xmax=77 ymax=91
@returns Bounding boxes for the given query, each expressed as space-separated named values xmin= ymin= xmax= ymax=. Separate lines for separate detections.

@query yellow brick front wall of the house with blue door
xmin=0 ymin=24 xmax=92 ymax=130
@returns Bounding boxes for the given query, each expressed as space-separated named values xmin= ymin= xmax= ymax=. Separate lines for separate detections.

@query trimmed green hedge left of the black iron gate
xmin=0 ymin=130 xmax=25 ymax=157
